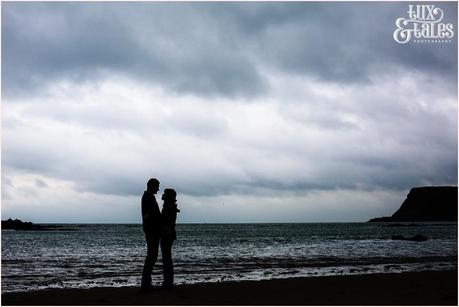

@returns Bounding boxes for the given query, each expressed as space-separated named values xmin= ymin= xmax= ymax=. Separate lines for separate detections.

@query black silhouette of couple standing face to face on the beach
xmin=141 ymin=178 xmax=180 ymax=291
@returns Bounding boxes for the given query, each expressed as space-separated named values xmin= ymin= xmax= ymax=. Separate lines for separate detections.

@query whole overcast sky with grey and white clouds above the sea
xmin=2 ymin=2 xmax=458 ymax=223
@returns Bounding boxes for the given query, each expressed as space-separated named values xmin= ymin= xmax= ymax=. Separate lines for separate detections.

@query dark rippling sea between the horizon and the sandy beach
xmin=1 ymin=222 xmax=458 ymax=293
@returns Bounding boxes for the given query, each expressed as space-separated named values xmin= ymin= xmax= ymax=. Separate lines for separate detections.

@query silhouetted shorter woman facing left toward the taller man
xmin=161 ymin=189 xmax=180 ymax=288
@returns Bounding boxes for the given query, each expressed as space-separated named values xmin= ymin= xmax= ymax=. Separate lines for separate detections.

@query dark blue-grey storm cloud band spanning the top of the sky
xmin=2 ymin=3 xmax=457 ymax=97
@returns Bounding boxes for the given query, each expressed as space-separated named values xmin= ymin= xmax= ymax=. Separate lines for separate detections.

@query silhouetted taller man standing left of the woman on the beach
xmin=141 ymin=178 xmax=161 ymax=290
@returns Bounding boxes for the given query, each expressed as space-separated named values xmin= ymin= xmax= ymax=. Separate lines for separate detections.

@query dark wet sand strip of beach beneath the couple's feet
xmin=1 ymin=271 xmax=458 ymax=305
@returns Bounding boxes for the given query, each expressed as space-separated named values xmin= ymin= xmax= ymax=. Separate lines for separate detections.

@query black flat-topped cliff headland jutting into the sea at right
xmin=370 ymin=186 xmax=458 ymax=222
